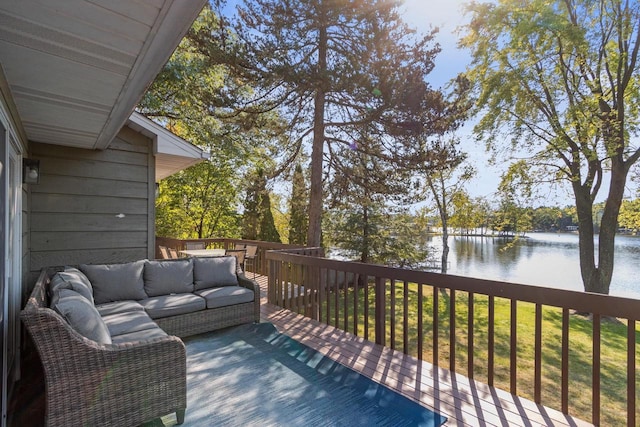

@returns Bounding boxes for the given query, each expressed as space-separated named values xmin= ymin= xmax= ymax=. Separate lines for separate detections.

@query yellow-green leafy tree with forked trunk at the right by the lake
xmin=461 ymin=0 xmax=640 ymax=294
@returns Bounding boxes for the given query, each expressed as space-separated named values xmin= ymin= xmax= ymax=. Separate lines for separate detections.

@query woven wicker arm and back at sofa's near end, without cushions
xmin=21 ymin=272 xmax=187 ymax=426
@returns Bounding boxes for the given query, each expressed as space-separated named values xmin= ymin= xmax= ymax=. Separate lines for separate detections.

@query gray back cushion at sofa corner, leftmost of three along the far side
xmin=80 ymin=260 xmax=147 ymax=304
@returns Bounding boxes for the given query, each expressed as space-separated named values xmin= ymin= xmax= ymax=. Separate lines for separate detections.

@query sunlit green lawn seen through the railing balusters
xmin=288 ymin=282 xmax=640 ymax=425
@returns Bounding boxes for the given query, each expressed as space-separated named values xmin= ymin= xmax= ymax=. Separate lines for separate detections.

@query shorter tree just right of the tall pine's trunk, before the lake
xmin=325 ymin=130 xmax=426 ymax=267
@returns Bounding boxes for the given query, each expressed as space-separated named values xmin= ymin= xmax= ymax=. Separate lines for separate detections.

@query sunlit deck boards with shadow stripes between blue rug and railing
xmin=256 ymin=276 xmax=592 ymax=427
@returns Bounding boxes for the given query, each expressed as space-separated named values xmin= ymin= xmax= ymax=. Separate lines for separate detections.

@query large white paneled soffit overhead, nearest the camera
xmin=0 ymin=0 xmax=206 ymax=149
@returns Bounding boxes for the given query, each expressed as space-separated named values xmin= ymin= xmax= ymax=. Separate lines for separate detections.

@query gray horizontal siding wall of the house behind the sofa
xmin=30 ymin=127 xmax=155 ymax=286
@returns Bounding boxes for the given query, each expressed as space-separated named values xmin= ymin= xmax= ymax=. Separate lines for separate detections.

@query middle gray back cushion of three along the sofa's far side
xmin=144 ymin=258 xmax=193 ymax=297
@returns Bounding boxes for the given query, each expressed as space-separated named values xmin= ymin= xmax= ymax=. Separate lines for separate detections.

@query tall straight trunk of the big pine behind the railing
xmin=307 ymin=8 xmax=327 ymax=247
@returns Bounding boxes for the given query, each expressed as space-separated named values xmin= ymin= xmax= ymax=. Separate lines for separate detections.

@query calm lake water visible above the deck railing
xmin=428 ymin=233 xmax=640 ymax=299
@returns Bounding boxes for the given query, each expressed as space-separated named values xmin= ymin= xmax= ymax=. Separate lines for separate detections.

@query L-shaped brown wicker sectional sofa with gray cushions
xmin=21 ymin=257 xmax=260 ymax=426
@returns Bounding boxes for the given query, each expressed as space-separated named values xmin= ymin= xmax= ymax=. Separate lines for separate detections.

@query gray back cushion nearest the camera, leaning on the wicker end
xmin=52 ymin=289 xmax=111 ymax=344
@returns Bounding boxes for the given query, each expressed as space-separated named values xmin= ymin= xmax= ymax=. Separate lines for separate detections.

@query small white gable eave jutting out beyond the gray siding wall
xmin=127 ymin=112 xmax=209 ymax=182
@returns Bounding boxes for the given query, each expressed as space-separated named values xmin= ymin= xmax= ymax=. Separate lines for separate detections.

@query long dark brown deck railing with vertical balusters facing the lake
xmin=266 ymin=249 xmax=640 ymax=426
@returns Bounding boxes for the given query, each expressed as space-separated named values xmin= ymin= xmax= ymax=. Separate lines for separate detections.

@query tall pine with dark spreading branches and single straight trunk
xmin=208 ymin=0 xmax=443 ymax=246
